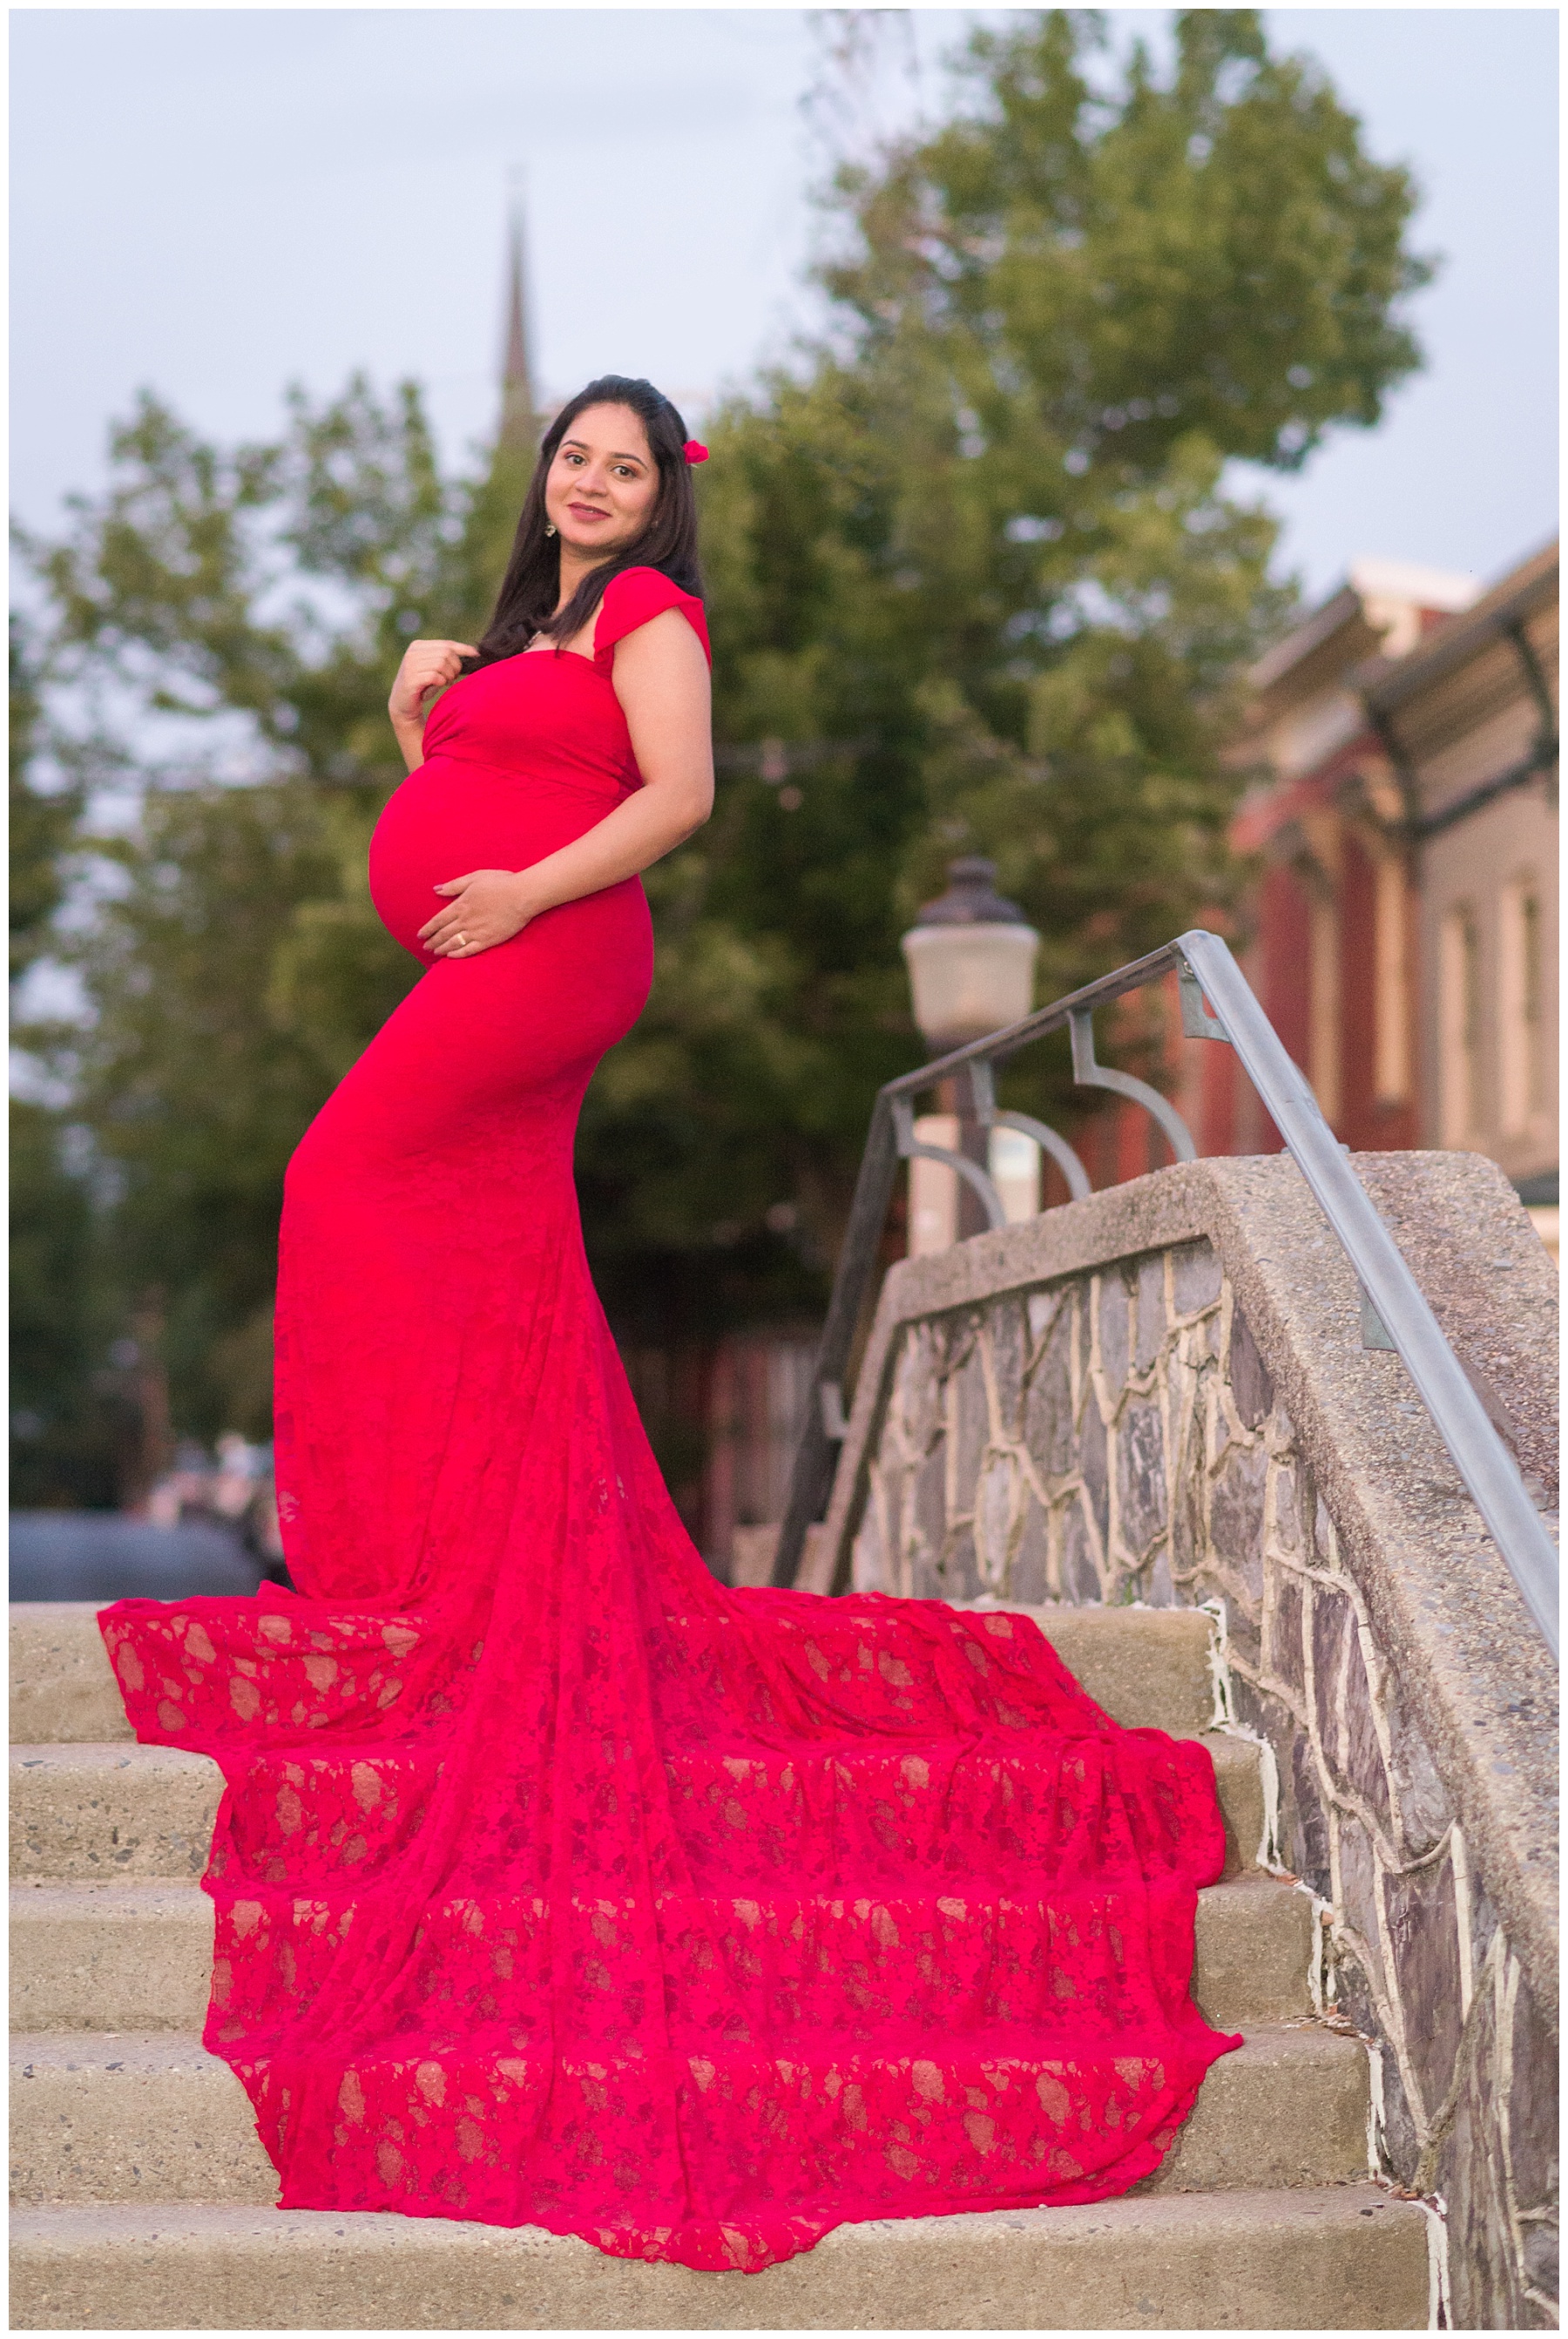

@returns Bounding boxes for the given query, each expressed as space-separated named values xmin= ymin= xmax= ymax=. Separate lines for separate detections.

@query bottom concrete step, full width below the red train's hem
xmin=11 ymin=2185 xmax=1428 ymax=2329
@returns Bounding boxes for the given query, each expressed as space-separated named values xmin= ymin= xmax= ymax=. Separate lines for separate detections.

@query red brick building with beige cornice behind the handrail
xmin=1186 ymin=545 xmax=1558 ymax=1240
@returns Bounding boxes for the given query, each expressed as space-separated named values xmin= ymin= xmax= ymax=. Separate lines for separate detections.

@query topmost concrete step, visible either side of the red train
xmin=11 ymin=1600 xmax=1214 ymax=1745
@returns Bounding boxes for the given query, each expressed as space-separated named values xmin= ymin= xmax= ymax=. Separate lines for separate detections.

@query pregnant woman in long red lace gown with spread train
xmin=103 ymin=379 xmax=1236 ymax=2271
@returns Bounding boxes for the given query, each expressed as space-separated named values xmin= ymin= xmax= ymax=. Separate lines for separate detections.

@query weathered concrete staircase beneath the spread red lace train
xmin=11 ymin=1605 xmax=1428 ymax=2329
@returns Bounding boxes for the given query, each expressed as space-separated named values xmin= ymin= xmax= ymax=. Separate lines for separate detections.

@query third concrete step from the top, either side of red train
xmin=11 ymin=1876 xmax=1313 ymax=2031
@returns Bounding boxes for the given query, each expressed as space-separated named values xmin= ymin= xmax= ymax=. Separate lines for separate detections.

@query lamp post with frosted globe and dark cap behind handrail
xmin=901 ymin=856 xmax=1039 ymax=1251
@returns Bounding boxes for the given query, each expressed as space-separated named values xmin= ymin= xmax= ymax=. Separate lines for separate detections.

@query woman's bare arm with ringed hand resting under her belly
xmin=419 ymin=608 xmax=713 ymax=959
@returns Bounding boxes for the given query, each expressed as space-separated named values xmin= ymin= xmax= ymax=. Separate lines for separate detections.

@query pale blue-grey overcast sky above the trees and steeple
xmin=11 ymin=7 xmax=1557 ymax=592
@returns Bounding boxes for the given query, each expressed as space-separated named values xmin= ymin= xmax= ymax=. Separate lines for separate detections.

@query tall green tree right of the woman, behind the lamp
xmin=632 ymin=11 xmax=1428 ymax=1256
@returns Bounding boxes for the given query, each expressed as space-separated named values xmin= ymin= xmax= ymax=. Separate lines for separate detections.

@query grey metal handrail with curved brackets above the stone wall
xmin=773 ymin=929 xmax=1558 ymax=1659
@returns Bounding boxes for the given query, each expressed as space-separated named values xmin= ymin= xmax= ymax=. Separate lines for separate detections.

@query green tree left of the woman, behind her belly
xmin=24 ymin=379 xmax=466 ymax=1437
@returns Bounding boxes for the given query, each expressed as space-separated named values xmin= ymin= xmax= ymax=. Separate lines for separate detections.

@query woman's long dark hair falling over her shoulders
xmin=463 ymin=375 xmax=702 ymax=673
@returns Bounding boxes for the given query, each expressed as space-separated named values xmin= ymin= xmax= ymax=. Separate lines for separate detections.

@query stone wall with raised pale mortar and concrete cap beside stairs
xmin=821 ymin=1155 xmax=1557 ymax=2329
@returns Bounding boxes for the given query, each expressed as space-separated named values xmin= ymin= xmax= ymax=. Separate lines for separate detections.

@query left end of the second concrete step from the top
xmin=11 ymin=1745 xmax=222 ymax=1883
